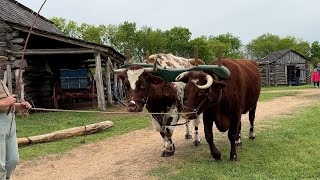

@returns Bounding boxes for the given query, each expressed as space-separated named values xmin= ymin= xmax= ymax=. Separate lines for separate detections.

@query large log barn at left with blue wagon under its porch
xmin=0 ymin=0 xmax=126 ymax=110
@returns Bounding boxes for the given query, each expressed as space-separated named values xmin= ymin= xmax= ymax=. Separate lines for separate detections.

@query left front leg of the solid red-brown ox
xmin=203 ymin=112 xmax=221 ymax=160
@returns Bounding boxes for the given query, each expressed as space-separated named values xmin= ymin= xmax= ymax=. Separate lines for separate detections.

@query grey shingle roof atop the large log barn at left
xmin=0 ymin=0 xmax=62 ymax=34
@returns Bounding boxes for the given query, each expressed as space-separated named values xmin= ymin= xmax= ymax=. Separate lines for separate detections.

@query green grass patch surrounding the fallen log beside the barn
xmin=16 ymin=112 xmax=151 ymax=160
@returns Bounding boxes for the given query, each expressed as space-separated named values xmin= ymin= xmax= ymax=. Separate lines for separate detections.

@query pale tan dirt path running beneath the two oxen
xmin=11 ymin=89 xmax=320 ymax=180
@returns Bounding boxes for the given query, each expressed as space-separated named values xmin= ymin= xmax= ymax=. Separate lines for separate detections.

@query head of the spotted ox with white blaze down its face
xmin=108 ymin=59 xmax=163 ymax=112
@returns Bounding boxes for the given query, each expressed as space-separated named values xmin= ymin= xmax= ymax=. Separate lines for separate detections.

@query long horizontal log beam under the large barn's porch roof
xmin=12 ymin=48 xmax=95 ymax=57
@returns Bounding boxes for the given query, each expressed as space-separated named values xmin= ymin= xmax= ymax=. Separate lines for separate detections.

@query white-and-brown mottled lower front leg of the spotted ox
xmin=160 ymin=127 xmax=175 ymax=157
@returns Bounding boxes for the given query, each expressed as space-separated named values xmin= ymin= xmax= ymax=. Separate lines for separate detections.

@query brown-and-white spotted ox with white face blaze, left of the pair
xmin=109 ymin=54 xmax=204 ymax=157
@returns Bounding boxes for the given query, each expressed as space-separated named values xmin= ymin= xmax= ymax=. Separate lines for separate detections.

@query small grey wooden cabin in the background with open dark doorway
xmin=257 ymin=49 xmax=310 ymax=86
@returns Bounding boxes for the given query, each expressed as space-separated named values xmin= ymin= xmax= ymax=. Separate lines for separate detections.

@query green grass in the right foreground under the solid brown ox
xmin=148 ymin=103 xmax=320 ymax=180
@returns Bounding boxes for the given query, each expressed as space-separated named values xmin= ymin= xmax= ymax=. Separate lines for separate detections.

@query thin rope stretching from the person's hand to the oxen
xmin=30 ymin=108 xmax=195 ymax=115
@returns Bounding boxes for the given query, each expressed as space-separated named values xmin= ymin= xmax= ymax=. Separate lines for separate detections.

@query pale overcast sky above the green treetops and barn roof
xmin=18 ymin=0 xmax=320 ymax=44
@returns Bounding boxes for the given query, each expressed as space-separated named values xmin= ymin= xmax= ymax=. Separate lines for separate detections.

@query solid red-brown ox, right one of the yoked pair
xmin=176 ymin=59 xmax=261 ymax=161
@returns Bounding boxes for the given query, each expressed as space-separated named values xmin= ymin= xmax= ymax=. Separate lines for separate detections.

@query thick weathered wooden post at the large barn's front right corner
xmin=94 ymin=52 xmax=106 ymax=111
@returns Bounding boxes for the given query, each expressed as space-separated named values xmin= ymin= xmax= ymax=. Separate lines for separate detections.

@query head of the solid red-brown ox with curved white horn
xmin=176 ymin=71 xmax=226 ymax=119
